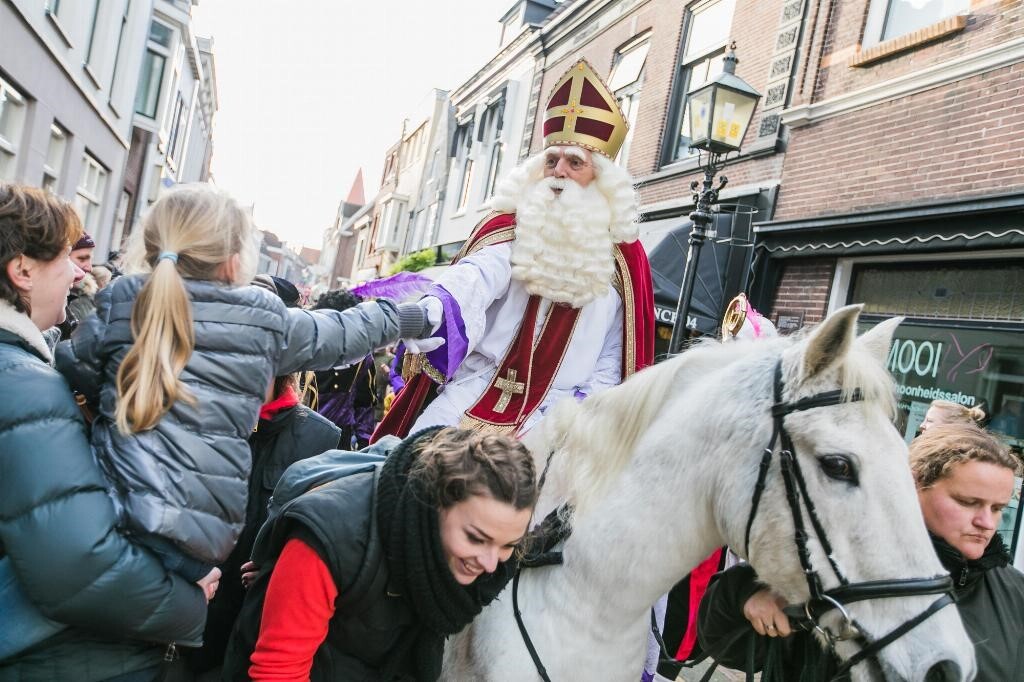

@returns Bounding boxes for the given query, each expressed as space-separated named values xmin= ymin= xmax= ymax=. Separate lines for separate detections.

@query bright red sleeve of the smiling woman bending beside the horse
xmin=249 ymin=539 xmax=338 ymax=682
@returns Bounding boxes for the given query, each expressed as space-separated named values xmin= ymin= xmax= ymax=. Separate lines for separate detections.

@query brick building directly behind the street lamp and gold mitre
xmin=527 ymin=0 xmax=804 ymax=350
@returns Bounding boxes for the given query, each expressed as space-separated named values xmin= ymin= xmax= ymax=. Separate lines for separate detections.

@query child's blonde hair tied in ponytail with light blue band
xmin=115 ymin=184 xmax=257 ymax=433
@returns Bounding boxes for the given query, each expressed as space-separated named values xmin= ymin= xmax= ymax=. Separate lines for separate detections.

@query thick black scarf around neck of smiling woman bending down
xmin=377 ymin=427 xmax=513 ymax=682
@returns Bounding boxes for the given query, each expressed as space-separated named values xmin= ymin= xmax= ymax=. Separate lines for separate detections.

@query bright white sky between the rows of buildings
xmin=193 ymin=0 xmax=515 ymax=249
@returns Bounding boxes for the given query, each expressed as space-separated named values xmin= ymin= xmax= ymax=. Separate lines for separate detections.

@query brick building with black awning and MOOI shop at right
xmin=754 ymin=0 xmax=1024 ymax=462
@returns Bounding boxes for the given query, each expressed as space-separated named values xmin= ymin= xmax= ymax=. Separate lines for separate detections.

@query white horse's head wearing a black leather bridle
xmin=726 ymin=306 xmax=975 ymax=682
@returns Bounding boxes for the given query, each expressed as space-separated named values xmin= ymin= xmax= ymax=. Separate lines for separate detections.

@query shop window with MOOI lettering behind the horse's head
xmin=849 ymin=260 xmax=1024 ymax=547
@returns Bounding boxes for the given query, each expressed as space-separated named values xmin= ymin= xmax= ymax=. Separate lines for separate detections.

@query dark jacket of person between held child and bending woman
xmin=183 ymin=404 xmax=341 ymax=672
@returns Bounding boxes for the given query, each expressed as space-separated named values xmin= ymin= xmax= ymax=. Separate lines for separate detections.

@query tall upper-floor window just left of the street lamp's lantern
xmin=667 ymin=0 xmax=736 ymax=163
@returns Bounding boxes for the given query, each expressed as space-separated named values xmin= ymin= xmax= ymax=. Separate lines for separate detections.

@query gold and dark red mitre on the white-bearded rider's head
xmin=544 ymin=59 xmax=629 ymax=159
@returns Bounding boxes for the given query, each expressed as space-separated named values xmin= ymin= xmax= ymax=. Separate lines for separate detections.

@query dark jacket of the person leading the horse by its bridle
xmin=697 ymin=535 xmax=1024 ymax=682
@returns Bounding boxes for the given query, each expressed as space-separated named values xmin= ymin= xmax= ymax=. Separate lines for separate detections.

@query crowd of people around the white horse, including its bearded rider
xmin=0 ymin=54 xmax=1024 ymax=682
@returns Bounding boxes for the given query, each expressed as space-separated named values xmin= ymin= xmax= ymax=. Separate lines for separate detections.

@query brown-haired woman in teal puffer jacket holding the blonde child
xmin=0 ymin=185 xmax=206 ymax=682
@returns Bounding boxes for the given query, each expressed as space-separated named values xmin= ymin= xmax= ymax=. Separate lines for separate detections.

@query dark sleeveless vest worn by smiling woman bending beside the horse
xmin=223 ymin=438 xmax=416 ymax=682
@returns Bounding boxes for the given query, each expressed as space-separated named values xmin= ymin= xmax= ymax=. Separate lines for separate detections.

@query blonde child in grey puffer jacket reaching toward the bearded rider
xmin=57 ymin=184 xmax=430 ymax=622
